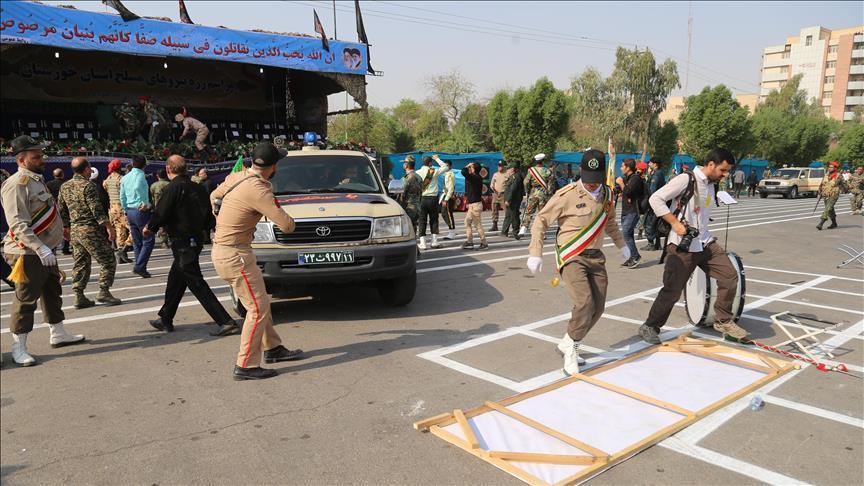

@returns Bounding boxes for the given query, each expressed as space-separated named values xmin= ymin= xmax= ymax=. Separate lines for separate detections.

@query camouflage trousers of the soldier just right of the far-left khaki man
xmin=71 ymin=226 xmax=117 ymax=292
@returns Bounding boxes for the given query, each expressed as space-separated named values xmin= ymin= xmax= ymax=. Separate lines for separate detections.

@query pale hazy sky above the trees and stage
xmin=44 ymin=0 xmax=864 ymax=110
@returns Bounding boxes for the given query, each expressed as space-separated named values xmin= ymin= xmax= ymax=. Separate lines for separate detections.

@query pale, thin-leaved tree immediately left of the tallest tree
xmin=569 ymin=67 xmax=627 ymax=151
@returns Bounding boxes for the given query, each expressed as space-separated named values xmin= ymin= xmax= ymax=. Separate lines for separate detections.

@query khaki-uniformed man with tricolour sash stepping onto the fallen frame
xmin=528 ymin=150 xmax=630 ymax=375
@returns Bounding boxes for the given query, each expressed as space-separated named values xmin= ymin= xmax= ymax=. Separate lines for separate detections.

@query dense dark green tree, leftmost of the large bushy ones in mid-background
xmin=487 ymin=78 xmax=568 ymax=162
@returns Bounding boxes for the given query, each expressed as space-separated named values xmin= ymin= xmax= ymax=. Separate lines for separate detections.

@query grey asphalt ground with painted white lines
xmin=0 ymin=196 xmax=864 ymax=485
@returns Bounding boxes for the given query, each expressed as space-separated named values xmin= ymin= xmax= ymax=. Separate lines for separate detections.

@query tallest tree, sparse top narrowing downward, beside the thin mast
xmin=611 ymin=47 xmax=681 ymax=160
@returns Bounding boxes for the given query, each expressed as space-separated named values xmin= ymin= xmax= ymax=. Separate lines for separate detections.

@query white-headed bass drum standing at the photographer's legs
xmin=684 ymin=252 xmax=747 ymax=327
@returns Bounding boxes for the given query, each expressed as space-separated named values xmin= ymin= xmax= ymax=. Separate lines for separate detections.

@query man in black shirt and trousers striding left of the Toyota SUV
xmin=143 ymin=155 xmax=240 ymax=336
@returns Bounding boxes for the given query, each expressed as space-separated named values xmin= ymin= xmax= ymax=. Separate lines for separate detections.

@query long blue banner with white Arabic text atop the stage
xmin=0 ymin=1 xmax=367 ymax=74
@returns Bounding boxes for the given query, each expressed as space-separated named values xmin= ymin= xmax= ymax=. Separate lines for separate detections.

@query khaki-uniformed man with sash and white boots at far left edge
xmin=2 ymin=135 xmax=84 ymax=366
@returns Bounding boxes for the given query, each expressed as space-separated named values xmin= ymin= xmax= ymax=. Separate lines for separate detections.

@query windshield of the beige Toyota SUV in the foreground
xmin=271 ymin=152 xmax=381 ymax=194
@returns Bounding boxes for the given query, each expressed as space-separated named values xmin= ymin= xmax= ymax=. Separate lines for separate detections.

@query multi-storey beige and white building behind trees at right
xmin=759 ymin=25 xmax=864 ymax=121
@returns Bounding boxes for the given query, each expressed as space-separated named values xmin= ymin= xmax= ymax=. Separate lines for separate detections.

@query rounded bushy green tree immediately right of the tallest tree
xmin=678 ymin=84 xmax=753 ymax=161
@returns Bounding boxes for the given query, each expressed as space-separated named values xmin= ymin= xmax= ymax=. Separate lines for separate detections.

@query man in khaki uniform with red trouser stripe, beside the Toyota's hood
xmin=210 ymin=142 xmax=302 ymax=380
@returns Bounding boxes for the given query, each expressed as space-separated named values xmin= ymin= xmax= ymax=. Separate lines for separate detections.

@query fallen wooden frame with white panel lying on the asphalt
xmin=414 ymin=334 xmax=796 ymax=484
